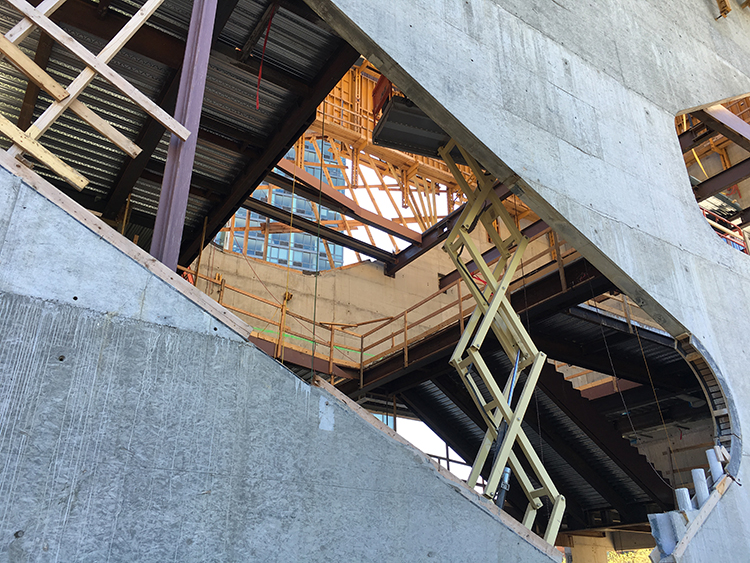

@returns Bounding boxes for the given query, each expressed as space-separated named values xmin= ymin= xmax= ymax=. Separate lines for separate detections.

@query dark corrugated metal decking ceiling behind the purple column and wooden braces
xmin=0 ymin=0 xmax=356 ymax=262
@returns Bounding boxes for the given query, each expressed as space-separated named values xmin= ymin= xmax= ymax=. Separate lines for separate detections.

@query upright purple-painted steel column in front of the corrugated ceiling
xmin=151 ymin=0 xmax=218 ymax=270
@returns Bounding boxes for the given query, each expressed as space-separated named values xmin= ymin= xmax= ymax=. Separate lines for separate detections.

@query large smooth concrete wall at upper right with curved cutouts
xmin=307 ymin=0 xmax=750 ymax=560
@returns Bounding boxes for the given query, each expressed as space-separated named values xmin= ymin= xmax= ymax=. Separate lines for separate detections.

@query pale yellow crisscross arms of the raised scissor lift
xmin=439 ymin=140 xmax=565 ymax=544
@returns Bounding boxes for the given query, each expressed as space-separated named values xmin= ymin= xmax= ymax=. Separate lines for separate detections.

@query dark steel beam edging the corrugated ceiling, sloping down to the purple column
xmin=180 ymin=41 xmax=359 ymax=265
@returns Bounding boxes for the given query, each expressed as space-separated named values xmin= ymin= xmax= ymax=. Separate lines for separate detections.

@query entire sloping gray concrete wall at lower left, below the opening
xmin=0 ymin=173 xmax=560 ymax=563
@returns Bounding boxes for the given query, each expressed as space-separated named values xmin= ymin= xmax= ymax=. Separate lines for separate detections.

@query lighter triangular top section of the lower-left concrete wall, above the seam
xmin=0 ymin=168 xmax=240 ymax=340
